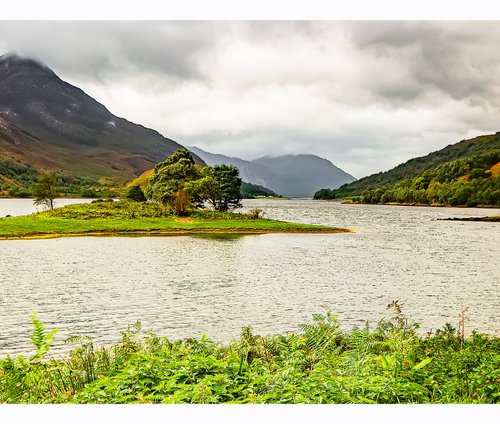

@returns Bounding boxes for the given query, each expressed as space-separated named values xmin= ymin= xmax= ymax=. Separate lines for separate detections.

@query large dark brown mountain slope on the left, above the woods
xmin=0 ymin=54 xmax=202 ymax=181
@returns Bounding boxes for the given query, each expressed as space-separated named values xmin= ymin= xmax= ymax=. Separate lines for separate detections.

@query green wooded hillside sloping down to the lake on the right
xmin=314 ymin=132 xmax=500 ymax=206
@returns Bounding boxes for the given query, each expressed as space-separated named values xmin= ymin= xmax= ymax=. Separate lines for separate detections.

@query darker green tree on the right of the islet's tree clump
xmin=187 ymin=165 xmax=242 ymax=212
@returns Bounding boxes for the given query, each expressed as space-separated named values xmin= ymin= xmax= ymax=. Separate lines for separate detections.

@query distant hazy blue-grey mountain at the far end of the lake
xmin=189 ymin=146 xmax=355 ymax=197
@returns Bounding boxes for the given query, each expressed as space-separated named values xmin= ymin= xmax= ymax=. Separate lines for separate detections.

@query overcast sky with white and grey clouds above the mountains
xmin=0 ymin=21 xmax=500 ymax=178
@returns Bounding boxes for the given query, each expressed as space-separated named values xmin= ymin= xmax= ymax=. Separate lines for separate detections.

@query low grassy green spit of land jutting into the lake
xmin=0 ymin=200 xmax=347 ymax=239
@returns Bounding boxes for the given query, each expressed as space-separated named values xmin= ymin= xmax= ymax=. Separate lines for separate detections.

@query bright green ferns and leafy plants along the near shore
xmin=0 ymin=302 xmax=500 ymax=404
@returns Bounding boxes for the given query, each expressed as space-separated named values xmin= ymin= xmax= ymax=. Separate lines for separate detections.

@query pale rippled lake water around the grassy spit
xmin=0 ymin=199 xmax=500 ymax=354
